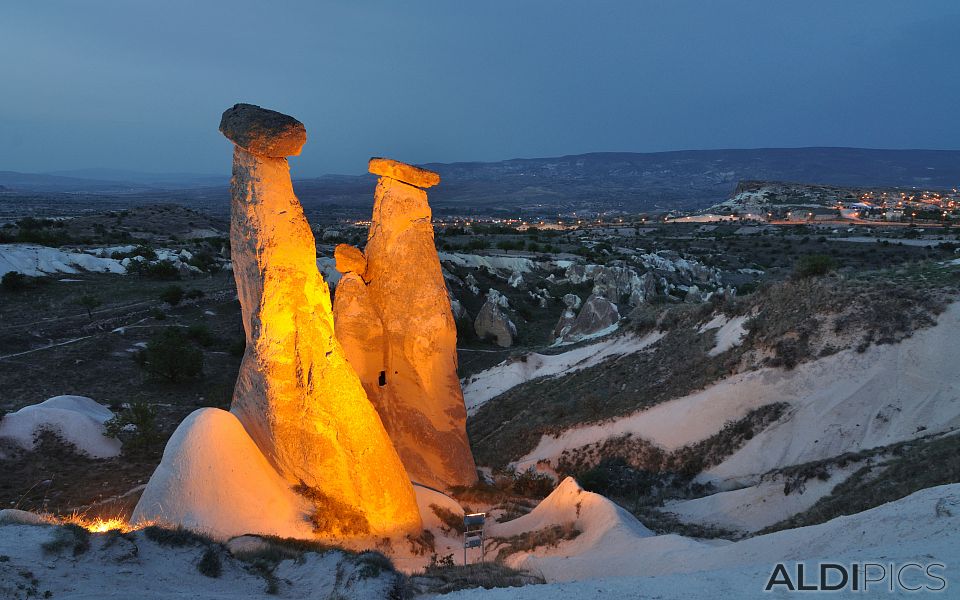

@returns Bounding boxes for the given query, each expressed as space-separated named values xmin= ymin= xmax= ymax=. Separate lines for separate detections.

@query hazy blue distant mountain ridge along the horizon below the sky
xmin=0 ymin=147 xmax=960 ymax=212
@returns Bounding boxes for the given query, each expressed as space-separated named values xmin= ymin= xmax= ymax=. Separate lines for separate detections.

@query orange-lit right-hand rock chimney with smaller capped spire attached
xmin=334 ymin=158 xmax=477 ymax=489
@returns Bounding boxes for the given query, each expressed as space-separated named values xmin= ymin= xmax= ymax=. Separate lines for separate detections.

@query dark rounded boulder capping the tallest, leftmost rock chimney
xmin=220 ymin=104 xmax=307 ymax=158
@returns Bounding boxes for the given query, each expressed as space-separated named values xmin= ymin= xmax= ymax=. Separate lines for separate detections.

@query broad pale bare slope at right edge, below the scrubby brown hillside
xmin=517 ymin=304 xmax=960 ymax=484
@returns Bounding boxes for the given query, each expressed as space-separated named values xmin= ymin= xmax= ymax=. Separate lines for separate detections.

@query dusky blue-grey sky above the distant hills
xmin=0 ymin=0 xmax=960 ymax=177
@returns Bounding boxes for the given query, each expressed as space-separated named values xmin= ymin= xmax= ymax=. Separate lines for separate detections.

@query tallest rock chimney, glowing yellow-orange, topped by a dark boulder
xmin=221 ymin=104 xmax=421 ymax=539
